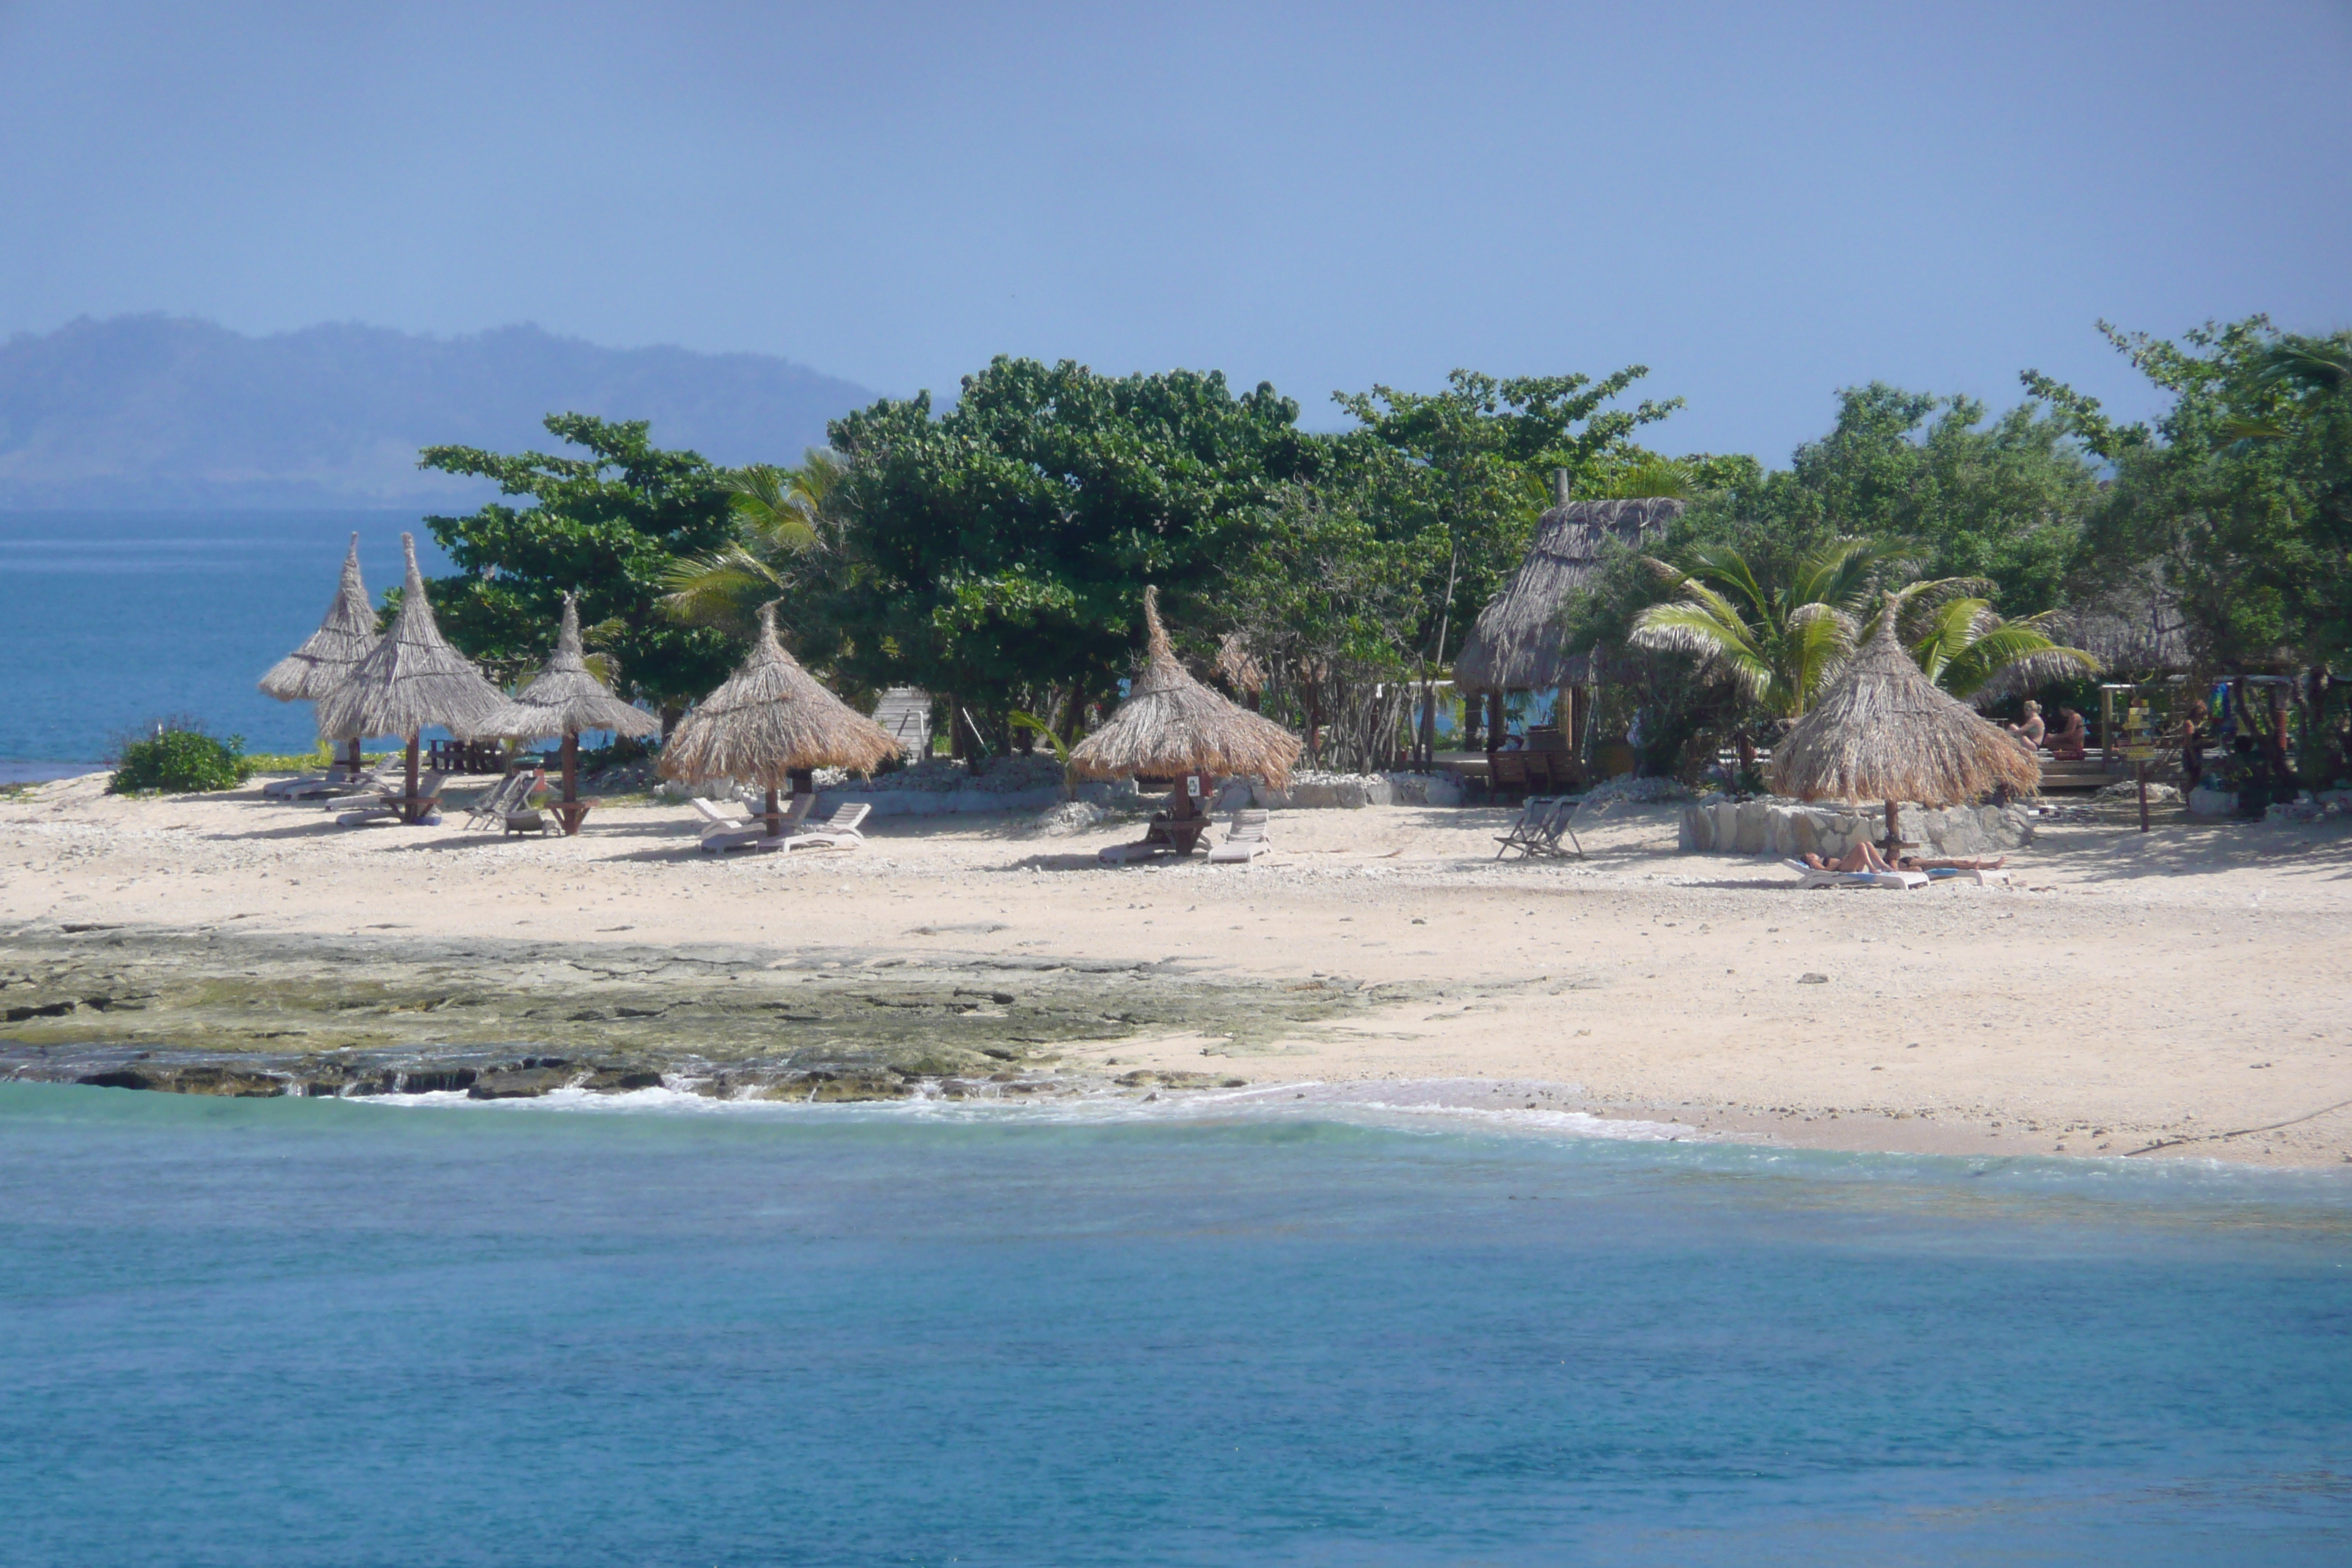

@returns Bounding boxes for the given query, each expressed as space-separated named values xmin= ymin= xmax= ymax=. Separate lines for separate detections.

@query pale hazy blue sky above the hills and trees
xmin=0 ymin=0 xmax=2352 ymax=461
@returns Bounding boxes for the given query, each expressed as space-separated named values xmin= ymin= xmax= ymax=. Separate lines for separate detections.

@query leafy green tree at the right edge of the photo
xmin=2025 ymin=315 xmax=2352 ymax=670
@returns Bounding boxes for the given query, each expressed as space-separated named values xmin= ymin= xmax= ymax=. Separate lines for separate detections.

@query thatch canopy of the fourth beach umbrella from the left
xmin=661 ymin=604 xmax=899 ymax=790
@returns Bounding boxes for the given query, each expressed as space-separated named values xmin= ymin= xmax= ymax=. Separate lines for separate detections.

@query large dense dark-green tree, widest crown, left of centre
xmin=828 ymin=358 xmax=1322 ymax=736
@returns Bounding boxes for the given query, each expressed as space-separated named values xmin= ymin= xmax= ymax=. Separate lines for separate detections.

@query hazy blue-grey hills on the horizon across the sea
xmin=0 ymin=315 xmax=875 ymax=510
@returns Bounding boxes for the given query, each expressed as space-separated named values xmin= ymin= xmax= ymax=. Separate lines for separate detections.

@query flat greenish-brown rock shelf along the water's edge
xmin=0 ymin=924 xmax=1409 ymax=1103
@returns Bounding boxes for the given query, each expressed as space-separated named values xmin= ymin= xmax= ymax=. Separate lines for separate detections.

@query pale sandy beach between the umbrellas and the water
xmin=0 ymin=778 xmax=2352 ymax=1166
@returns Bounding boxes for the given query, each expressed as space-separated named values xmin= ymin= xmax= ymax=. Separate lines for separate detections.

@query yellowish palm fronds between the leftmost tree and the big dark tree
xmin=661 ymin=451 xmax=842 ymax=637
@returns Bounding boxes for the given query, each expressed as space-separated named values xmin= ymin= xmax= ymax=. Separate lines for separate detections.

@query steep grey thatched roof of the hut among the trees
xmin=1453 ymin=498 xmax=1684 ymax=693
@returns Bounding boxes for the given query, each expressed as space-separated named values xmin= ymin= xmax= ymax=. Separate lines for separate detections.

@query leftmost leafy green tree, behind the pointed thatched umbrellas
xmin=418 ymin=414 xmax=736 ymax=724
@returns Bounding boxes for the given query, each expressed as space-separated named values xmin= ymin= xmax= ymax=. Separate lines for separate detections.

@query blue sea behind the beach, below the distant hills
xmin=0 ymin=513 xmax=449 ymax=783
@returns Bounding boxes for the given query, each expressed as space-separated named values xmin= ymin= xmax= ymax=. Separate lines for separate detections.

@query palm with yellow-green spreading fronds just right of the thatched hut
xmin=1632 ymin=538 xmax=1907 ymax=720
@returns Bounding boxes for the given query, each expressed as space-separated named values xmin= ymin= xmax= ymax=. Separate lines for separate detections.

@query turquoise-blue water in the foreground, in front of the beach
xmin=0 ymin=1086 xmax=2352 ymax=1568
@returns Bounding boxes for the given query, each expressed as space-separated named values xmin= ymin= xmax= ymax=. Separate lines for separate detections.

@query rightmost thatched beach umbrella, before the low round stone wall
xmin=1771 ymin=595 xmax=2041 ymax=853
